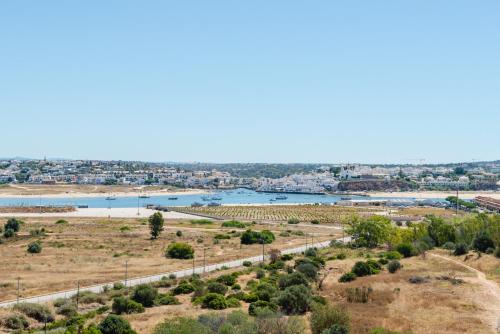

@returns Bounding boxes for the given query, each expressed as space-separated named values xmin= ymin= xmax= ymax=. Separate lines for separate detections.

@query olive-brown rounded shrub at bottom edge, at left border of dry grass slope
xmin=310 ymin=304 xmax=349 ymax=334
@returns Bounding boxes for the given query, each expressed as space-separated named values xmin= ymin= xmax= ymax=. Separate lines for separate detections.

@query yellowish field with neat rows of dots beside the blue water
xmin=175 ymin=205 xmax=384 ymax=223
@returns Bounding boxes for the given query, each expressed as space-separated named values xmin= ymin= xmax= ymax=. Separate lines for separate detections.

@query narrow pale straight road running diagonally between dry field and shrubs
xmin=0 ymin=237 xmax=350 ymax=307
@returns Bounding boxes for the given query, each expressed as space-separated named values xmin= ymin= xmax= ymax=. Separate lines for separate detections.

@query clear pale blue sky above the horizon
xmin=0 ymin=0 xmax=500 ymax=163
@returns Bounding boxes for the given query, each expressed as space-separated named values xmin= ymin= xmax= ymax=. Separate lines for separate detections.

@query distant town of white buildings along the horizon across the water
xmin=0 ymin=159 xmax=500 ymax=194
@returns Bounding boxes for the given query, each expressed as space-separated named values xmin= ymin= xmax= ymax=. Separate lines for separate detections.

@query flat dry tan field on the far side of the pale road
xmin=0 ymin=218 xmax=339 ymax=301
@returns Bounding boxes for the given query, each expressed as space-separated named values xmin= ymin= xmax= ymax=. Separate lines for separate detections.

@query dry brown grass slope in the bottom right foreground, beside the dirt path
xmin=321 ymin=251 xmax=500 ymax=334
